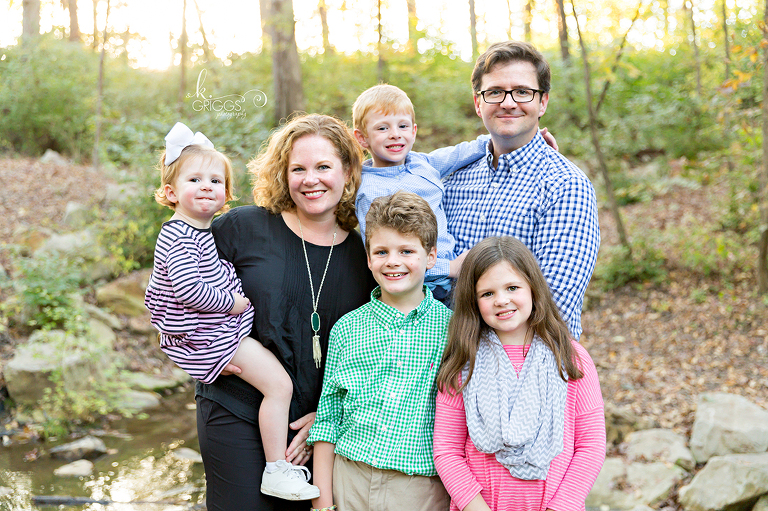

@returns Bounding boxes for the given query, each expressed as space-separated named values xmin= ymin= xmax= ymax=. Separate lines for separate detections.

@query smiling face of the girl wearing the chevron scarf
xmin=475 ymin=261 xmax=533 ymax=345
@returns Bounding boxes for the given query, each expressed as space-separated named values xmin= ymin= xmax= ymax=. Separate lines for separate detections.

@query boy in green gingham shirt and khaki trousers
xmin=307 ymin=192 xmax=451 ymax=511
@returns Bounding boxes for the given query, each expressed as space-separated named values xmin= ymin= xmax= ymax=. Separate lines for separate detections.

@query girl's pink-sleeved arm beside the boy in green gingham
xmin=433 ymin=389 xmax=488 ymax=511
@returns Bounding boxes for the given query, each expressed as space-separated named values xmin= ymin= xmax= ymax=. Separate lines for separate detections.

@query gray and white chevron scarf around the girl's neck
xmin=462 ymin=330 xmax=568 ymax=480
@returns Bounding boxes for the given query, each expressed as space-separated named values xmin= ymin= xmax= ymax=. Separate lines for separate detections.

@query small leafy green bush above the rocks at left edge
xmin=2 ymin=253 xmax=86 ymax=333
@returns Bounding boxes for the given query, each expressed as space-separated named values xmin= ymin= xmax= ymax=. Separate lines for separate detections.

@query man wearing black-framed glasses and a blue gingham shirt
xmin=443 ymin=41 xmax=600 ymax=340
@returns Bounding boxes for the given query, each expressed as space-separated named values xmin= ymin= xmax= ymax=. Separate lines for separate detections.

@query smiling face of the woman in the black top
xmin=286 ymin=135 xmax=347 ymax=221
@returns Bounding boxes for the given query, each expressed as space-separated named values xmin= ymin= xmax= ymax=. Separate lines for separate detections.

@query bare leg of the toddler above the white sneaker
xmin=232 ymin=337 xmax=293 ymax=462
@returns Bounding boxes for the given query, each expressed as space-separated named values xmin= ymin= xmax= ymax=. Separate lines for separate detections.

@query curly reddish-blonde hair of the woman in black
xmin=248 ymin=114 xmax=363 ymax=231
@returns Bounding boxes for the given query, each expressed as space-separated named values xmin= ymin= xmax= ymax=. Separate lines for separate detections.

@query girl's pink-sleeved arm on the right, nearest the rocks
xmin=547 ymin=342 xmax=605 ymax=511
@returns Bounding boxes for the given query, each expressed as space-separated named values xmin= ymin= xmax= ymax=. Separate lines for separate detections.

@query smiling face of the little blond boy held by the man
xmin=355 ymin=112 xmax=416 ymax=167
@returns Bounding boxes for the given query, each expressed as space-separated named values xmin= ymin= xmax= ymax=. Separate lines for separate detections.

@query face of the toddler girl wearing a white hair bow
xmin=164 ymin=157 xmax=227 ymax=229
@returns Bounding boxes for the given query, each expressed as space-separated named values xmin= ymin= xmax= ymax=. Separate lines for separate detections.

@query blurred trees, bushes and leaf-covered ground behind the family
xmin=0 ymin=0 xmax=768 ymax=430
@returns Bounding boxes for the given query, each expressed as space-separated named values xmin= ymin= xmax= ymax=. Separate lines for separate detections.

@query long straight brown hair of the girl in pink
xmin=437 ymin=236 xmax=583 ymax=392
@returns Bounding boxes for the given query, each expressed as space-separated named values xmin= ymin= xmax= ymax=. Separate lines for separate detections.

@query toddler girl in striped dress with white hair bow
xmin=144 ymin=122 xmax=320 ymax=500
